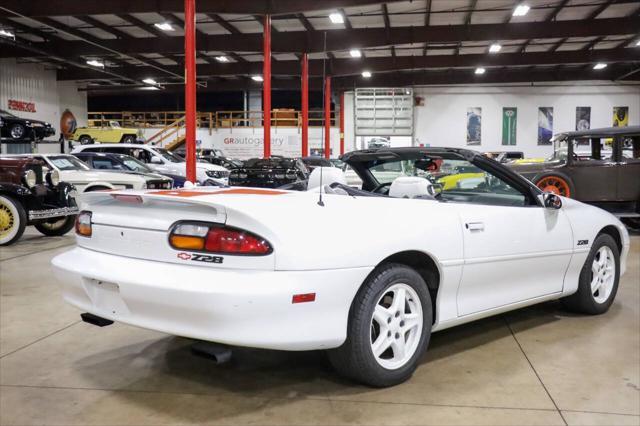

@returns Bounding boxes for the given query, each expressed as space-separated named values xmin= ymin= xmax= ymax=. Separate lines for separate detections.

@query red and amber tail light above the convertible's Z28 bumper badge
xmin=169 ymin=222 xmax=273 ymax=256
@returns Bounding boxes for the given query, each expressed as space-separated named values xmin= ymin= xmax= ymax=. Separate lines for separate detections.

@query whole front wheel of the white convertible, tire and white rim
xmin=560 ymin=234 xmax=620 ymax=315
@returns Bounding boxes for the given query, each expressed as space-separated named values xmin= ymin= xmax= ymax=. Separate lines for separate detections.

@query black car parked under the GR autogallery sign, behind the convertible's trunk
xmin=229 ymin=156 xmax=309 ymax=188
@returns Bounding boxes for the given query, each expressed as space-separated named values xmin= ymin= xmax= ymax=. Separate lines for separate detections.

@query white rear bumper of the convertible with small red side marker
xmin=53 ymin=247 xmax=371 ymax=350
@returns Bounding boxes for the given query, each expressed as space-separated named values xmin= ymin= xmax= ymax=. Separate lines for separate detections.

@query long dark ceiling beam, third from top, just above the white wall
xmin=58 ymin=49 xmax=640 ymax=80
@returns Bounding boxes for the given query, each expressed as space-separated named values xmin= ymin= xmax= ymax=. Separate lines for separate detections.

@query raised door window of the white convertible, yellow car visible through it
xmin=431 ymin=159 xmax=528 ymax=207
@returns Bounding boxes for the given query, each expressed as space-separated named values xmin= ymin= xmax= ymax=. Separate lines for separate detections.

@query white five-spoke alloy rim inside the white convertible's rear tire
xmin=371 ymin=283 xmax=423 ymax=370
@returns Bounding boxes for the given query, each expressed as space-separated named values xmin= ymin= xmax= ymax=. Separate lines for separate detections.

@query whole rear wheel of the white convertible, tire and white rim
xmin=329 ymin=264 xmax=433 ymax=387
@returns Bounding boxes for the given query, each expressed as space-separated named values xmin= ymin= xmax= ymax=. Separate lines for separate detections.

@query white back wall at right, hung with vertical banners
xmin=345 ymin=82 xmax=640 ymax=156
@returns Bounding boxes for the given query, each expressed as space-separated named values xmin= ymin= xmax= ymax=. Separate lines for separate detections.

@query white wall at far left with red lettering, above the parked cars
xmin=0 ymin=59 xmax=87 ymax=139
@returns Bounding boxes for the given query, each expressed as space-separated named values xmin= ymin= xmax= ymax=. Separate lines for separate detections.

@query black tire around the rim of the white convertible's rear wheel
xmin=328 ymin=263 xmax=433 ymax=387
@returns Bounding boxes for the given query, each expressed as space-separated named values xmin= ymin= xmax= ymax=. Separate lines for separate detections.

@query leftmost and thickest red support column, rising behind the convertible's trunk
xmin=184 ymin=0 xmax=197 ymax=183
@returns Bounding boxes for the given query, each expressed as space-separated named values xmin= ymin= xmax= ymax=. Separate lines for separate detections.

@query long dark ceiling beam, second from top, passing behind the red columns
xmin=0 ymin=16 xmax=640 ymax=57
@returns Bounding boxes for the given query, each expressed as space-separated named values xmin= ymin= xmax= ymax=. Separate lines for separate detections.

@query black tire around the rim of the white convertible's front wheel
xmin=560 ymin=234 xmax=620 ymax=315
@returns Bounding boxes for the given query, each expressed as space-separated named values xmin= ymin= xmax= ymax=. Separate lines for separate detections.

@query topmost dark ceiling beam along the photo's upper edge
xmin=0 ymin=0 xmax=399 ymax=17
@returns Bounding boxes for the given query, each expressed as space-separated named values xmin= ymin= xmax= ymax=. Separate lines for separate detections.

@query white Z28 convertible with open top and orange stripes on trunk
xmin=53 ymin=148 xmax=629 ymax=386
